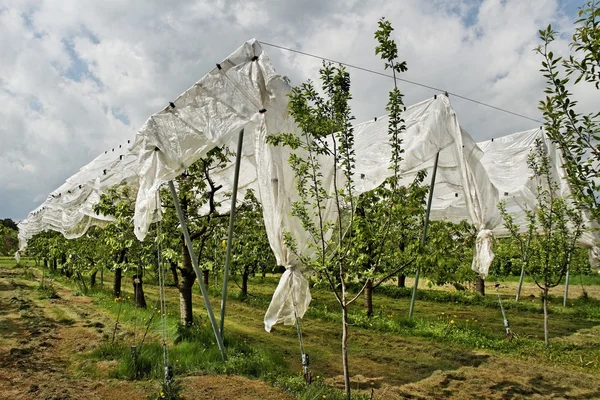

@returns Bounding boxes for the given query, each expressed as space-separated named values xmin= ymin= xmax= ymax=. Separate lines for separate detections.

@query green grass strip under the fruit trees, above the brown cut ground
xmin=8 ymin=261 xmax=600 ymax=399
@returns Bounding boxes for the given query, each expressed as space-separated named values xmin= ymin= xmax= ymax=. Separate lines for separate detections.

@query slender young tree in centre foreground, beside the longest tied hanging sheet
xmin=269 ymin=19 xmax=407 ymax=399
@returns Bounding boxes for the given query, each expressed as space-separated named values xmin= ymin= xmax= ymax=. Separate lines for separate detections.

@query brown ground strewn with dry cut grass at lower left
xmin=0 ymin=267 xmax=288 ymax=400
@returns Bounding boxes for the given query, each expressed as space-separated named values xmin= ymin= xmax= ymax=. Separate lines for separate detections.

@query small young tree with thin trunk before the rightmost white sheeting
xmin=499 ymin=139 xmax=585 ymax=346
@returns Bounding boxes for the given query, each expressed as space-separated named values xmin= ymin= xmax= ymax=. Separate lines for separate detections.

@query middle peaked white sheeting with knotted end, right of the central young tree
xmin=355 ymin=96 xmax=501 ymax=278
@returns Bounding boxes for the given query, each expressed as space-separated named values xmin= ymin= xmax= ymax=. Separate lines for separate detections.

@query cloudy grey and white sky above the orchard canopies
xmin=0 ymin=0 xmax=600 ymax=220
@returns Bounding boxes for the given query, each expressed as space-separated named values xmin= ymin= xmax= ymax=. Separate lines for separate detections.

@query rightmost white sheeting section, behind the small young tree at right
xmin=478 ymin=128 xmax=600 ymax=270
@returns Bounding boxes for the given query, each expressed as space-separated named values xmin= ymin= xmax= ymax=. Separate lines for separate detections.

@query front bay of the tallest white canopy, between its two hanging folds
xmin=130 ymin=40 xmax=324 ymax=330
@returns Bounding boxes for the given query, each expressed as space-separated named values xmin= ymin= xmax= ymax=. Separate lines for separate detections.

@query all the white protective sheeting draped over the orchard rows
xmin=19 ymin=40 xmax=598 ymax=331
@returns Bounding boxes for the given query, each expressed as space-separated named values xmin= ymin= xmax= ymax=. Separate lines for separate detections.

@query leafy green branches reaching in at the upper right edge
xmin=537 ymin=0 xmax=600 ymax=222
